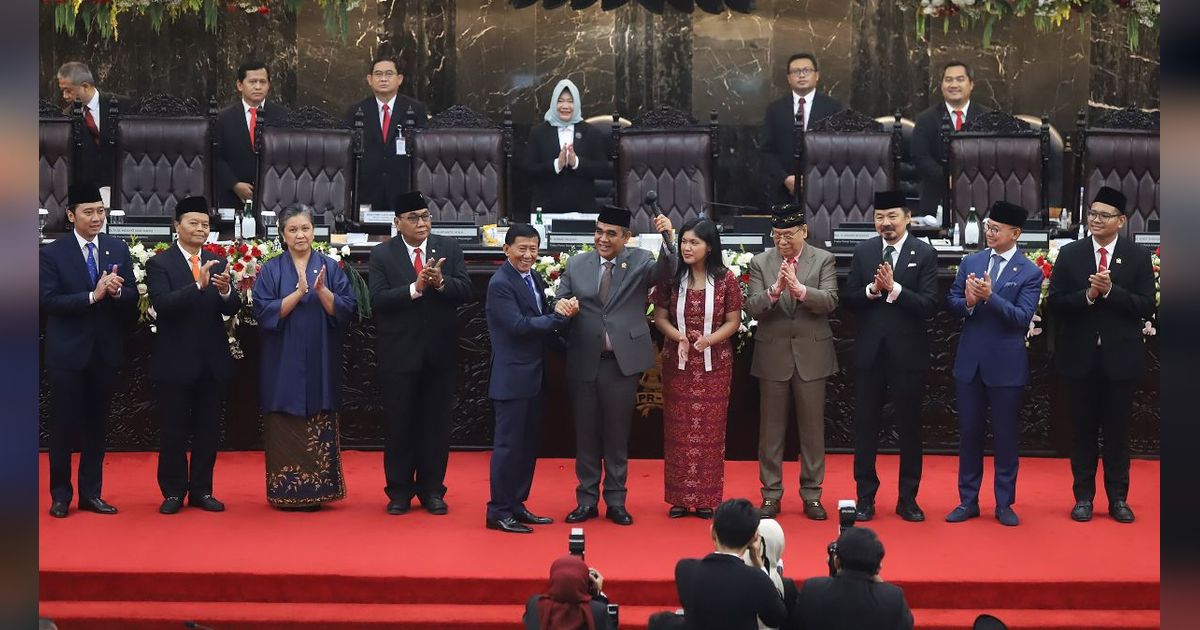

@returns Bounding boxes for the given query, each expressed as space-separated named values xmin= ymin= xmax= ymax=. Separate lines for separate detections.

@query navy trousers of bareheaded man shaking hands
xmin=487 ymin=396 xmax=541 ymax=520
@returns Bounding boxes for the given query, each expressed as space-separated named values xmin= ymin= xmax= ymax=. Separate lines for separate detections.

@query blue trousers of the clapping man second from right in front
xmin=954 ymin=372 xmax=1025 ymax=508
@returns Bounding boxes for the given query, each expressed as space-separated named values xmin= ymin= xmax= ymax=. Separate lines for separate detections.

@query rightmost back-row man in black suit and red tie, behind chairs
xmin=911 ymin=61 xmax=988 ymax=215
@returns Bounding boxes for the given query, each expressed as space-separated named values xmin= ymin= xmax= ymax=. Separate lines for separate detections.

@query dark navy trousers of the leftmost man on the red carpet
xmin=46 ymin=359 xmax=116 ymax=503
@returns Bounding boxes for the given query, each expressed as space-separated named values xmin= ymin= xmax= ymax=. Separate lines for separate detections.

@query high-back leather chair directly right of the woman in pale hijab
xmin=612 ymin=107 xmax=721 ymax=234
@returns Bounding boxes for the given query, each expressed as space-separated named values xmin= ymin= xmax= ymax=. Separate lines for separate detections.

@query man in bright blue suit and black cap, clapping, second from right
xmin=946 ymin=202 xmax=1043 ymax=527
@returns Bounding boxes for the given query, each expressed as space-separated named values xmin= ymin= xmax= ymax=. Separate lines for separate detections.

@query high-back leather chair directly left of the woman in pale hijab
xmin=403 ymin=106 xmax=512 ymax=226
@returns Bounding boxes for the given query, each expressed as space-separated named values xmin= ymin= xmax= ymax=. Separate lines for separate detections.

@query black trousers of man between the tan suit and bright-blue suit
xmin=854 ymin=360 xmax=925 ymax=503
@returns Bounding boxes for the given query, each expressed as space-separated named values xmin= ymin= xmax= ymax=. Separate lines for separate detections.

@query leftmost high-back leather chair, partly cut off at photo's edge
xmin=37 ymin=101 xmax=80 ymax=233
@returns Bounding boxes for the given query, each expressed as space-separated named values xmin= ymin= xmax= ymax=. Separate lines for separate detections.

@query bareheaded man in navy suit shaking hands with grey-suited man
xmin=486 ymin=223 xmax=578 ymax=534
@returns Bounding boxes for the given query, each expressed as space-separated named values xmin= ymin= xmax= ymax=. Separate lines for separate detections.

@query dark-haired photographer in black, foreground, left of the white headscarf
xmin=676 ymin=499 xmax=787 ymax=630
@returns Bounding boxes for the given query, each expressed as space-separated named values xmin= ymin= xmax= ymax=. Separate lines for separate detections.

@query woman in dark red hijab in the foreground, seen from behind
xmin=522 ymin=556 xmax=613 ymax=630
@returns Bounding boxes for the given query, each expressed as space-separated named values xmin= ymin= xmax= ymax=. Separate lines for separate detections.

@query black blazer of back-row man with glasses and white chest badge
xmin=347 ymin=94 xmax=429 ymax=208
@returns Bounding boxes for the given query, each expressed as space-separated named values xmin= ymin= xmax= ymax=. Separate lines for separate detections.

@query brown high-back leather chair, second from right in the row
xmin=942 ymin=112 xmax=1050 ymax=226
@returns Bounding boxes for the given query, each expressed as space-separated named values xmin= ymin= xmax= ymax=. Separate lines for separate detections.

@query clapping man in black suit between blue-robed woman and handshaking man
xmin=370 ymin=191 xmax=470 ymax=515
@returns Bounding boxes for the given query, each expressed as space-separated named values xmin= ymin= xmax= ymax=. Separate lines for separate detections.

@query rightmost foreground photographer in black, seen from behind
xmin=790 ymin=527 xmax=913 ymax=630
